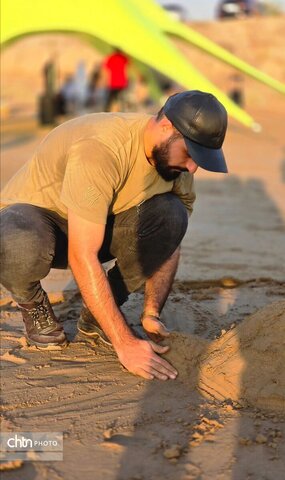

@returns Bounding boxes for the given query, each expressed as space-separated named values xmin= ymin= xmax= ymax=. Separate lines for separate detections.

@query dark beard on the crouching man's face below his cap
xmin=151 ymin=133 xmax=181 ymax=182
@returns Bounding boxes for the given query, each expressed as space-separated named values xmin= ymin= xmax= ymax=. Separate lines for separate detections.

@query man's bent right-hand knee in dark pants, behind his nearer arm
xmin=106 ymin=193 xmax=188 ymax=297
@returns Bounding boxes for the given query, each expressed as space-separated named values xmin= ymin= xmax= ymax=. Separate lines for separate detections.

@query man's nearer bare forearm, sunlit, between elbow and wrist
xmin=69 ymin=256 xmax=133 ymax=348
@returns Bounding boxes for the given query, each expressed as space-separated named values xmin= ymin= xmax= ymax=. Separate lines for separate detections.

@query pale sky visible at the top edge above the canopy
xmin=155 ymin=0 xmax=285 ymax=20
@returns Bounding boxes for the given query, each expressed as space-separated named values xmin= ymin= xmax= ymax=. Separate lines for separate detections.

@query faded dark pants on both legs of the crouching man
xmin=0 ymin=193 xmax=188 ymax=305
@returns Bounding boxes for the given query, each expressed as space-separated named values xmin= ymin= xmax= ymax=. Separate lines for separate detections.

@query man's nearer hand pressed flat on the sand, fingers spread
xmin=116 ymin=338 xmax=178 ymax=380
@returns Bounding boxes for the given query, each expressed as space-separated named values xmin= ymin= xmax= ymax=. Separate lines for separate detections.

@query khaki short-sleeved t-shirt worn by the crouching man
xmin=1 ymin=113 xmax=195 ymax=224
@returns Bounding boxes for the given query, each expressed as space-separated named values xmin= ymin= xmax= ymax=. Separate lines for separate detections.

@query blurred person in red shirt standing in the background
xmin=103 ymin=49 xmax=130 ymax=112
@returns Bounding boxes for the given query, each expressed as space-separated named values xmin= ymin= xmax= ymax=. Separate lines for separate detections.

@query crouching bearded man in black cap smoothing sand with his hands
xmin=1 ymin=91 xmax=227 ymax=380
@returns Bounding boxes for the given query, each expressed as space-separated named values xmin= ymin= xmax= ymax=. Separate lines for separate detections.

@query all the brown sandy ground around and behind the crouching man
xmin=1 ymin=15 xmax=285 ymax=480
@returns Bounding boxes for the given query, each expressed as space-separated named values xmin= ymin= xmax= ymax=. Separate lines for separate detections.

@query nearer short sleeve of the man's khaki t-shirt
xmin=60 ymin=139 xmax=120 ymax=224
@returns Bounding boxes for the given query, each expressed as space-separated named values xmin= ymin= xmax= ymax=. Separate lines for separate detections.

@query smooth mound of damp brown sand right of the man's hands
xmin=165 ymin=301 xmax=285 ymax=412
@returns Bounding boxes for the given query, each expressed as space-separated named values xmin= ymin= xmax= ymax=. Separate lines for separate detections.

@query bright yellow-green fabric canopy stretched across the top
xmin=1 ymin=0 xmax=284 ymax=127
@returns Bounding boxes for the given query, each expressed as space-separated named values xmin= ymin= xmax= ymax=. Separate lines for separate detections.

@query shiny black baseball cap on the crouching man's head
xmin=163 ymin=90 xmax=228 ymax=173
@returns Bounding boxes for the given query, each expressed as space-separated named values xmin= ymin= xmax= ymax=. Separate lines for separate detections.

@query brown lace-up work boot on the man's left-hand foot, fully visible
xmin=19 ymin=293 xmax=67 ymax=348
